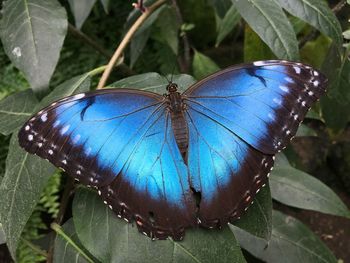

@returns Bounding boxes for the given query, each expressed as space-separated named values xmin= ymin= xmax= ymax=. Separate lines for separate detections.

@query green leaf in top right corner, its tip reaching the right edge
xmin=277 ymin=0 xmax=343 ymax=49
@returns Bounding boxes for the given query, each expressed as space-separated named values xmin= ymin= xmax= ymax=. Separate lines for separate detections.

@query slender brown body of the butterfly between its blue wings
xmin=167 ymin=83 xmax=188 ymax=162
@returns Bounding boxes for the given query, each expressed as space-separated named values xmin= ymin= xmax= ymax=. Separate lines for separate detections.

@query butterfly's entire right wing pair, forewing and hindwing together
xmin=183 ymin=61 xmax=326 ymax=226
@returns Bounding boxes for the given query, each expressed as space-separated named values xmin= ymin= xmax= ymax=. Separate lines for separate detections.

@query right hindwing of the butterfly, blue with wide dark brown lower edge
xmin=187 ymin=110 xmax=274 ymax=227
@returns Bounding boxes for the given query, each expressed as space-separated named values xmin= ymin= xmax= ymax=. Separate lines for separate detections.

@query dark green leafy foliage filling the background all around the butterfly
xmin=0 ymin=0 xmax=350 ymax=262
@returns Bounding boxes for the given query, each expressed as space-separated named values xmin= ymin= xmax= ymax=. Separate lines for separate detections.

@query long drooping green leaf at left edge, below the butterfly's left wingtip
xmin=0 ymin=135 xmax=55 ymax=258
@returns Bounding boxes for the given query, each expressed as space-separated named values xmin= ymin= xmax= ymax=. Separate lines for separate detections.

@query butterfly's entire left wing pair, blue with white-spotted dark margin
xmin=19 ymin=89 xmax=194 ymax=239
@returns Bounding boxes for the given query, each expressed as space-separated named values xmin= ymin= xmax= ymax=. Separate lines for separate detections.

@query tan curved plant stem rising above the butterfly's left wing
xmin=97 ymin=0 xmax=166 ymax=89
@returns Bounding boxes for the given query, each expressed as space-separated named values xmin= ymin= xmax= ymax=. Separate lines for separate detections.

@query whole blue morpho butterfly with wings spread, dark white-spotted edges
xmin=19 ymin=61 xmax=327 ymax=240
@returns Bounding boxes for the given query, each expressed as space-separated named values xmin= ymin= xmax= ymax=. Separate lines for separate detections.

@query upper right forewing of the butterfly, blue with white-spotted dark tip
xmin=183 ymin=61 xmax=326 ymax=154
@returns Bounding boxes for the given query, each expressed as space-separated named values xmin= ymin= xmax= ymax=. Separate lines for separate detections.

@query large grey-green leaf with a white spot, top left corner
xmin=0 ymin=0 xmax=67 ymax=92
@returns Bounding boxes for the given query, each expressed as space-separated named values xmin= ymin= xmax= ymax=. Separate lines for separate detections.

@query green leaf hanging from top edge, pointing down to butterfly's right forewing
xmin=232 ymin=0 xmax=299 ymax=60
